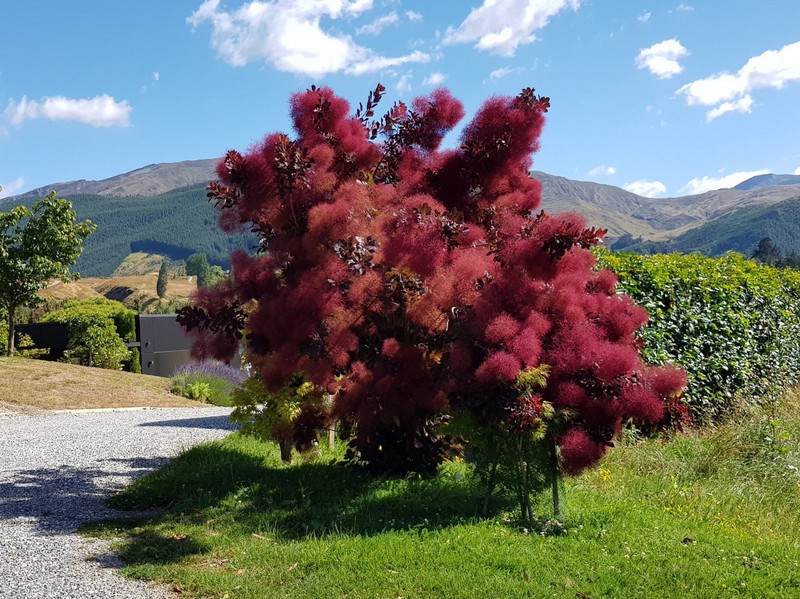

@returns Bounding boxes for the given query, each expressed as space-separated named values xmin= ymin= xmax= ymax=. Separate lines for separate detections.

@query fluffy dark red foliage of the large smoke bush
xmin=180 ymin=85 xmax=685 ymax=473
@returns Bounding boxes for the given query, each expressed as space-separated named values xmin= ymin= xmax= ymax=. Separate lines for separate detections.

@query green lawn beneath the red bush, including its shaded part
xmin=89 ymin=399 xmax=800 ymax=599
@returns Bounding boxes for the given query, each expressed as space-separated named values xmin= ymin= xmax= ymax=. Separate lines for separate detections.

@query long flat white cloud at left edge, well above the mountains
xmin=3 ymin=94 xmax=133 ymax=127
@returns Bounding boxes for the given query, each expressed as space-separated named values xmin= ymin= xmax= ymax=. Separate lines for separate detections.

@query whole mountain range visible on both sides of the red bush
xmin=0 ymin=159 xmax=800 ymax=276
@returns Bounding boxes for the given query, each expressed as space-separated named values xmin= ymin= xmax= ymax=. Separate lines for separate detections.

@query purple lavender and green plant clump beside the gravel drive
xmin=170 ymin=362 xmax=247 ymax=406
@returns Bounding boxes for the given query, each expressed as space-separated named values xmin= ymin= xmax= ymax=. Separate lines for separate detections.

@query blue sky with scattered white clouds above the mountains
xmin=0 ymin=0 xmax=800 ymax=202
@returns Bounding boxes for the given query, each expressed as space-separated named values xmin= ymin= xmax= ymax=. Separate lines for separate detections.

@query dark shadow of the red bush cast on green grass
xmin=88 ymin=438 xmax=507 ymax=565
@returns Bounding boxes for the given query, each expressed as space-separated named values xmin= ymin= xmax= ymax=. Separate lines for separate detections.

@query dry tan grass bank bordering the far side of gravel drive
xmin=0 ymin=358 xmax=203 ymax=410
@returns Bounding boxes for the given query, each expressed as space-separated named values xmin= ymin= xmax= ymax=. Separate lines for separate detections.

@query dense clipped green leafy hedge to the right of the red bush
xmin=597 ymin=250 xmax=800 ymax=422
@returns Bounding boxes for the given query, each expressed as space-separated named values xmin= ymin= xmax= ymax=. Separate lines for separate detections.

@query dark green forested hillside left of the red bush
xmin=14 ymin=184 xmax=256 ymax=277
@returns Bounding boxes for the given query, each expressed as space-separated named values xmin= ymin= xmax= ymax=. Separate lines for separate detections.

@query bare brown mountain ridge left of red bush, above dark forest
xmin=8 ymin=158 xmax=219 ymax=202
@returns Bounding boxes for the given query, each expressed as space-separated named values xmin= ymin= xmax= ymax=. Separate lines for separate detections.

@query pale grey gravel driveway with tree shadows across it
xmin=0 ymin=408 xmax=239 ymax=599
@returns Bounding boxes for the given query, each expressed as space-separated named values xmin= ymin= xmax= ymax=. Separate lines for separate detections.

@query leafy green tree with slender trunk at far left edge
xmin=0 ymin=191 xmax=94 ymax=355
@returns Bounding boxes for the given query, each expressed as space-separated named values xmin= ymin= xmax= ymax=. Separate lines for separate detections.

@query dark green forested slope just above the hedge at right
xmin=628 ymin=197 xmax=800 ymax=256
